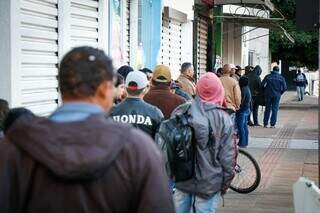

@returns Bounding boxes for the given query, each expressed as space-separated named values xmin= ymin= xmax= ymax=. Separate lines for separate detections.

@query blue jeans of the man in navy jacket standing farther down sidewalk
xmin=263 ymin=97 xmax=280 ymax=126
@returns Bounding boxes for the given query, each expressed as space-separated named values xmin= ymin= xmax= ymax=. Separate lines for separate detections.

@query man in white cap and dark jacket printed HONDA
xmin=110 ymin=71 xmax=163 ymax=138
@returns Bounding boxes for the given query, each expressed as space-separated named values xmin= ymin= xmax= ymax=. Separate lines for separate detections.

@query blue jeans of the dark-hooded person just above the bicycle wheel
xmin=236 ymin=109 xmax=250 ymax=147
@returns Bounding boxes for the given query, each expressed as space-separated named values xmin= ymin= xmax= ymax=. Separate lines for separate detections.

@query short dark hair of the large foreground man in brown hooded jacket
xmin=58 ymin=46 xmax=114 ymax=96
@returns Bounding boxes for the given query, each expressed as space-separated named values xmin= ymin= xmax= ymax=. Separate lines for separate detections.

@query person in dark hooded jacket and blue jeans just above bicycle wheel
xmin=236 ymin=76 xmax=252 ymax=148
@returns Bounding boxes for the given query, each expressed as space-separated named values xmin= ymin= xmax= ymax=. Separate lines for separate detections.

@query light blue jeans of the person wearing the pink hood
xmin=173 ymin=189 xmax=221 ymax=213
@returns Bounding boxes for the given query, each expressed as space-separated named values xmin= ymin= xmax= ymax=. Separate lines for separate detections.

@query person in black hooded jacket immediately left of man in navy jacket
xmin=245 ymin=65 xmax=262 ymax=126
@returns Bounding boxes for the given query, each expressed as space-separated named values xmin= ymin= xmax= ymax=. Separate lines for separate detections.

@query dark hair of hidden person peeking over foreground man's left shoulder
xmin=3 ymin=107 xmax=35 ymax=134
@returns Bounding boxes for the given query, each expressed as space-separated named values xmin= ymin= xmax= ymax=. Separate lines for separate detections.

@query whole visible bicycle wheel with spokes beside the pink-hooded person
xmin=230 ymin=149 xmax=261 ymax=194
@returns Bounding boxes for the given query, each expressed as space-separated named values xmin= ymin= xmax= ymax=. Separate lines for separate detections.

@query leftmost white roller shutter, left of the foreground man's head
xmin=20 ymin=0 xmax=58 ymax=115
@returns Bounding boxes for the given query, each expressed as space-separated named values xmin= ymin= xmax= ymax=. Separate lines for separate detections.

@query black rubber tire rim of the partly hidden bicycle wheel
xmin=230 ymin=149 xmax=261 ymax=194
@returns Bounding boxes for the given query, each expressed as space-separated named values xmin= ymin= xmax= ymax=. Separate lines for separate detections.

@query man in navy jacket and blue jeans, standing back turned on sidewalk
xmin=262 ymin=66 xmax=287 ymax=128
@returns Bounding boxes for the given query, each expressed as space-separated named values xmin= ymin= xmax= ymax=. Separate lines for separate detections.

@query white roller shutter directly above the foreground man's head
xmin=70 ymin=0 xmax=99 ymax=48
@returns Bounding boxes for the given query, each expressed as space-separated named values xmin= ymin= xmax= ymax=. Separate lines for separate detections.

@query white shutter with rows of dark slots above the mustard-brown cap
xmin=160 ymin=17 xmax=182 ymax=79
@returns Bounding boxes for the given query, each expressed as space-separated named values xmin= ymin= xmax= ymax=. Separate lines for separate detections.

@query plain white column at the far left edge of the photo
xmin=0 ymin=0 xmax=21 ymax=107
